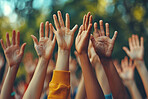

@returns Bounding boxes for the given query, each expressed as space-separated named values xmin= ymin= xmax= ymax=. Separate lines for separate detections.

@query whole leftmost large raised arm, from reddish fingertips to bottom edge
xmin=1 ymin=31 xmax=26 ymax=99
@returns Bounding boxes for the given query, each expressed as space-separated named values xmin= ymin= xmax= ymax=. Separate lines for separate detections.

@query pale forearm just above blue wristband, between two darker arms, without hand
xmin=95 ymin=63 xmax=111 ymax=95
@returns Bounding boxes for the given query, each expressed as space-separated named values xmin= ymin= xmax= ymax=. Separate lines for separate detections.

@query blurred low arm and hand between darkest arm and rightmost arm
xmin=117 ymin=57 xmax=142 ymax=99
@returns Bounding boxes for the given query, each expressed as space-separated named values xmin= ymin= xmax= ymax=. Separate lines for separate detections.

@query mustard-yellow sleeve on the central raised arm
xmin=48 ymin=70 xmax=70 ymax=99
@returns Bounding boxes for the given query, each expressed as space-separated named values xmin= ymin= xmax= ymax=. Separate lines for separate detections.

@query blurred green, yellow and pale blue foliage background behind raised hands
xmin=0 ymin=0 xmax=148 ymax=97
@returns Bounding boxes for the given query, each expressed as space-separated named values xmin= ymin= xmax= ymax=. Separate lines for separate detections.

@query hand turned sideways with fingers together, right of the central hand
xmin=75 ymin=12 xmax=92 ymax=54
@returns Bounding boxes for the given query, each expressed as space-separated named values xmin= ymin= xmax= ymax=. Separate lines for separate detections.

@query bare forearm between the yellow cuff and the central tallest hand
xmin=55 ymin=48 xmax=70 ymax=71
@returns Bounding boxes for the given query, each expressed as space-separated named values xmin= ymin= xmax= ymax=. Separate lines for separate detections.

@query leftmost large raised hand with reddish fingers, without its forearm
xmin=1 ymin=30 xmax=26 ymax=67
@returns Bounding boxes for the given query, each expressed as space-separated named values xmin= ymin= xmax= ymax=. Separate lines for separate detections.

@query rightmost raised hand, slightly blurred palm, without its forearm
xmin=123 ymin=35 xmax=144 ymax=60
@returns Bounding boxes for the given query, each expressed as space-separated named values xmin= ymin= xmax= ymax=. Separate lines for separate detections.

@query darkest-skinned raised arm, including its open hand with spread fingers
xmin=91 ymin=20 xmax=129 ymax=99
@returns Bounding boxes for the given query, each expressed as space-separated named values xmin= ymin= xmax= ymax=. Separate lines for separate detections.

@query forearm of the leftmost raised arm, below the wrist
xmin=1 ymin=66 xmax=18 ymax=99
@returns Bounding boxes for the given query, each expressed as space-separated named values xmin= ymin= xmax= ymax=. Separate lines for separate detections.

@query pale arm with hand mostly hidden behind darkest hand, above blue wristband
xmin=88 ymin=38 xmax=111 ymax=95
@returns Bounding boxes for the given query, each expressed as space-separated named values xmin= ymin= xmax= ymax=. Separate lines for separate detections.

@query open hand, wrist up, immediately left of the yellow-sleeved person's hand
xmin=31 ymin=21 xmax=56 ymax=60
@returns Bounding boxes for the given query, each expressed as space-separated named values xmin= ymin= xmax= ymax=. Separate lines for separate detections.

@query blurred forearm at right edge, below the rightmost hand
xmin=135 ymin=60 xmax=148 ymax=97
